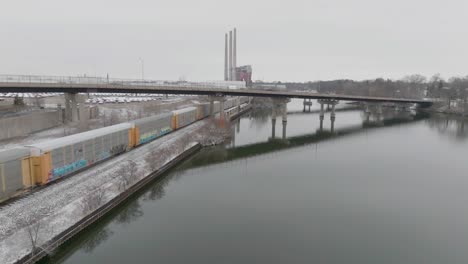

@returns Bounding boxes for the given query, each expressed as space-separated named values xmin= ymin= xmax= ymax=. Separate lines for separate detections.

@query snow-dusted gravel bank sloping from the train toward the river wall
xmin=0 ymin=120 xmax=208 ymax=263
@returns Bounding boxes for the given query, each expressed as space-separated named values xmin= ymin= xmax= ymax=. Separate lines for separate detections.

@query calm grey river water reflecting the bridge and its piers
xmin=43 ymin=100 xmax=468 ymax=264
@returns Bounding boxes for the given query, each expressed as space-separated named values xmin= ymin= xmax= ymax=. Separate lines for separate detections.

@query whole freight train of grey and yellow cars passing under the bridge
xmin=0 ymin=97 xmax=248 ymax=201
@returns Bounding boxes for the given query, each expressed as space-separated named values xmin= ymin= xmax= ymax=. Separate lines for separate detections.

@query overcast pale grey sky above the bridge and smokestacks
xmin=0 ymin=0 xmax=468 ymax=81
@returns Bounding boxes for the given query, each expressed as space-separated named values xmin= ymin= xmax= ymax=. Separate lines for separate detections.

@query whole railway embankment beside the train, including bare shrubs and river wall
xmin=0 ymin=104 xmax=249 ymax=263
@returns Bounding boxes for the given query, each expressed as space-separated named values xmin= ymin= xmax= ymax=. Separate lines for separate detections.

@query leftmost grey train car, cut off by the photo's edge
xmin=0 ymin=147 xmax=33 ymax=201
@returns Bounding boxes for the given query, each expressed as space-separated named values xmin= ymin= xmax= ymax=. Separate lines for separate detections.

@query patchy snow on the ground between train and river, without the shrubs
xmin=0 ymin=120 xmax=207 ymax=264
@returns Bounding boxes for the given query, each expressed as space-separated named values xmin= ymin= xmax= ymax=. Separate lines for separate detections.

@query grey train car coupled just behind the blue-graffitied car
xmin=131 ymin=113 xmax=173 ymax=146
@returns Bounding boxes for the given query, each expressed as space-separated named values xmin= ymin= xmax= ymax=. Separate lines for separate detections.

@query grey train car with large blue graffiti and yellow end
xmin=27 ymin=123 xmax=134 ymax=184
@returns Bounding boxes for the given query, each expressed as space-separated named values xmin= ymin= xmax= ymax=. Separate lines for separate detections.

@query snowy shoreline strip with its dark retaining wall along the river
xmin=0 ymin=120 xmax=207 ymax=264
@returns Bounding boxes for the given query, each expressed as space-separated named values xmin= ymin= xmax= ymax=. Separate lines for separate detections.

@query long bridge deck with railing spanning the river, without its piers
xmin=0 ymin=75 xmax=432 ymax=107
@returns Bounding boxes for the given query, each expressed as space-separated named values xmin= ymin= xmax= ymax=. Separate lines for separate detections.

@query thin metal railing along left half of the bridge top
xmin=0 ymin=74 xmax=241 ymax=89
